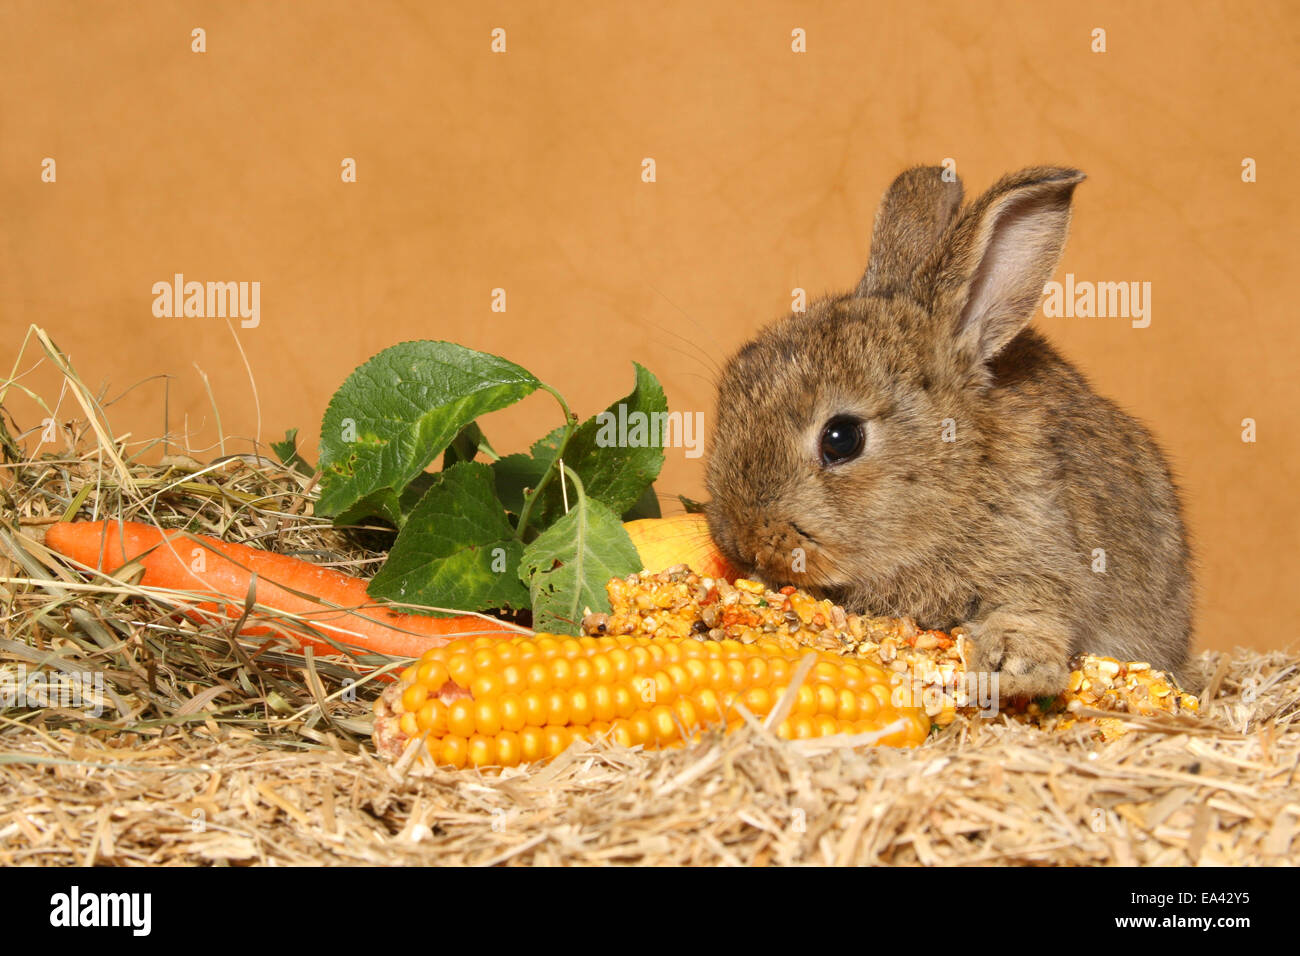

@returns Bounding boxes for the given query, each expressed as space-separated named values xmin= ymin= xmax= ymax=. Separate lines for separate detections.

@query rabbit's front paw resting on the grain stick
xmin=965 ymin=607 xmax=1070 ymax=700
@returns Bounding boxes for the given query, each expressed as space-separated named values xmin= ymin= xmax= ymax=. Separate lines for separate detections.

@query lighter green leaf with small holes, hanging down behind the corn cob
xmin=519 ymin=486 xmax=641 ymax=633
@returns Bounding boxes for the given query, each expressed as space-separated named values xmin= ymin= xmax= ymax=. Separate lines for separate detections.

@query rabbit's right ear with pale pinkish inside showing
xmin=914 ymin=166 xmax=1084 ymax=363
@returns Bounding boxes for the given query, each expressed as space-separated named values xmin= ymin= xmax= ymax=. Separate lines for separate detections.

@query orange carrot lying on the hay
xmin=46 ymin=522 xmax=516 ymax=657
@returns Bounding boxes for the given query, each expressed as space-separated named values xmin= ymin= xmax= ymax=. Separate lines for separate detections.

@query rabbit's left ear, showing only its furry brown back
xmin=858 ymin=166 xmax=962 ymax=295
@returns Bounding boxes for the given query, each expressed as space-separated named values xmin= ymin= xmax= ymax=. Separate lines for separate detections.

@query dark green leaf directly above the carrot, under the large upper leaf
xmin=368 ymin=462 xmax=528 ymax=611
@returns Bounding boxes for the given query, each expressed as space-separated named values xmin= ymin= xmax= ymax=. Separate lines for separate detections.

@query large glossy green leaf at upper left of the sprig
xmin=316 ymin=342 xmax=541 ymax=523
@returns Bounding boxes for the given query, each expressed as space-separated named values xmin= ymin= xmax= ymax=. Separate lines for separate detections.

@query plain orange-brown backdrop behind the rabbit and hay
xmin=0 ymin=0 xmax=1300 ymax=655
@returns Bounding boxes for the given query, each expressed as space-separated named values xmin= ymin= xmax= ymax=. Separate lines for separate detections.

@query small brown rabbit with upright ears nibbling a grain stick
xmin=707 ymin=168 xmax=1192 ymax=697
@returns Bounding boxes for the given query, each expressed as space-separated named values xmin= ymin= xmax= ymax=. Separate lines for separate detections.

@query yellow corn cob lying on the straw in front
xmin=374 ymin=633 xmax=930 ymax=767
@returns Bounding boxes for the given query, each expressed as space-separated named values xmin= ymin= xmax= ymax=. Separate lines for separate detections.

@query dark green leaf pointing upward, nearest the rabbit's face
xmin=533 ymin=363 xmax=668 ymax=525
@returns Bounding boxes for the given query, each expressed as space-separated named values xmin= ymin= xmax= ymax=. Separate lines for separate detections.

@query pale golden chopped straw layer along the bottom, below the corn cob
xmin=0 ymin=654 xmax=1300 ymax=865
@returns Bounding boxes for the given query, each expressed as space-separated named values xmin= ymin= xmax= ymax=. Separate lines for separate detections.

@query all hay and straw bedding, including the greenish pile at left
xmin=0 ymin=330 xmax=1300 ymax=865
